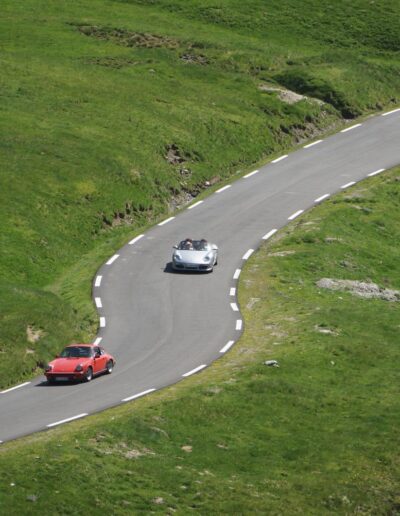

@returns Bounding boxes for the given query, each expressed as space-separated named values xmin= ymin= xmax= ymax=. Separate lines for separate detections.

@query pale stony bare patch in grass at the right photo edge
xmin=317 ymin=278 xmax=400 ymax=302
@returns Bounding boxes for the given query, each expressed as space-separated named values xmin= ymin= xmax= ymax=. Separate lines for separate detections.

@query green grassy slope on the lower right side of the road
xmin=0 ymin=168 xmax=400 ymax=515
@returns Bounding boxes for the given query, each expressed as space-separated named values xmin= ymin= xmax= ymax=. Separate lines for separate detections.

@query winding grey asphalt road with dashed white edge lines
xmin=0 ymin=109 xmax=400 ymax=442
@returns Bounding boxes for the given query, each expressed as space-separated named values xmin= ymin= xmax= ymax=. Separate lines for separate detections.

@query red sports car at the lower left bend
xmin=44 ymin=344 xmax=115 ymax=383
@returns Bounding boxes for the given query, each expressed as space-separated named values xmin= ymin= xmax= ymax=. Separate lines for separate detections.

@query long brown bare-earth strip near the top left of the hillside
xmin=78 ymin=25 xmax=179 ymax=48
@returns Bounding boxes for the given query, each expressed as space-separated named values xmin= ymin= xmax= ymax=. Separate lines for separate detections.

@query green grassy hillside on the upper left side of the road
xmin=0 ymin=0 xmax=400 ymax=387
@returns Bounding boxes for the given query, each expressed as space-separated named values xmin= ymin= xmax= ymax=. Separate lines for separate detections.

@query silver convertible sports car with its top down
xmin=172 ymin=238 xmax=218 ymax=272
